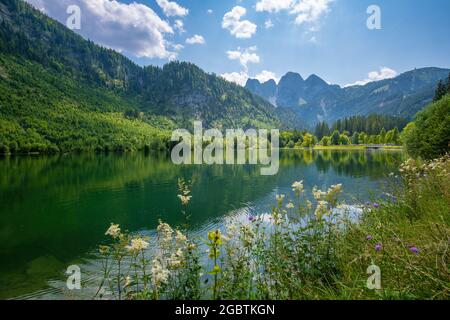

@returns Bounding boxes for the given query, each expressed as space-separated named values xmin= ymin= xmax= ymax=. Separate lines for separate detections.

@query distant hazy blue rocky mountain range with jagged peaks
xmin=246 ymin=68 xmax=450 ymax=126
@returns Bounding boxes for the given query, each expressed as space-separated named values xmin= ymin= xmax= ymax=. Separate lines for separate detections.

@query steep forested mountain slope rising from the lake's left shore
xmin=0 ymin=0 xmax=281 ymax=151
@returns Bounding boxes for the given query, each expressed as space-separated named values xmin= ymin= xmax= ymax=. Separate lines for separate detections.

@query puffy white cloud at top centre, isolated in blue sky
xmin=222 ymin=6 xmax=258 ymax=39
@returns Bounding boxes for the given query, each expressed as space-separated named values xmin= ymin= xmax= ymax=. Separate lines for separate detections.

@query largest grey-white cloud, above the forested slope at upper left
xmin=27 ymin=0 xmax=175 ymax=59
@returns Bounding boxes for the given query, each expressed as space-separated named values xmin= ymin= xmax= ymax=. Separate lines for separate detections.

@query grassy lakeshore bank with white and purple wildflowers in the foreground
xmin=97 ymin=156 xmax=450 ymax=300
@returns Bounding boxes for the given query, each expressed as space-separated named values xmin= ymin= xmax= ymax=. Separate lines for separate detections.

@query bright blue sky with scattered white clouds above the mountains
xmin=28 ymin=0 xmax=450 ymax=85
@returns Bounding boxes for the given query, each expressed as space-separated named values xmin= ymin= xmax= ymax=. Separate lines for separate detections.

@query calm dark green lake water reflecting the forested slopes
xmin=0 ymin=150 xmax=404 ymax=299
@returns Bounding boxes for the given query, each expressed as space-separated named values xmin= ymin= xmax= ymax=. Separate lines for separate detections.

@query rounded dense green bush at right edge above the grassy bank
xmin=403 ymin=95 xmax=450 ymax=159
